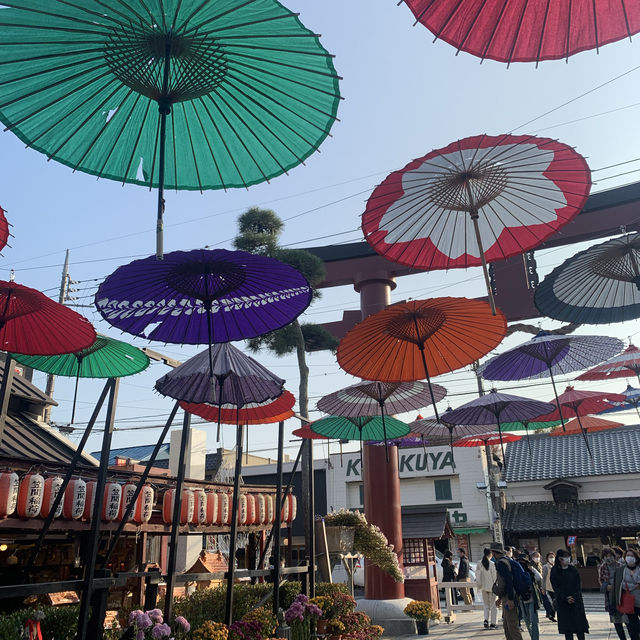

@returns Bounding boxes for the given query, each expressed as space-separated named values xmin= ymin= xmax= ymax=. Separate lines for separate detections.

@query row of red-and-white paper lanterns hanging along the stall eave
xmin=0 ymin=471 xmax=297 ymax=526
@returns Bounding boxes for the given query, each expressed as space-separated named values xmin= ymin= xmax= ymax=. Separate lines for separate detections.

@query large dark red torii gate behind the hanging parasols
xmin=307 ymin=183 xmax=640 ymax=600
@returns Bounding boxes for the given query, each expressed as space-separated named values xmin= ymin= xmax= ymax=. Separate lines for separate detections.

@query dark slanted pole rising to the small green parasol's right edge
xmin=78 ymin=378 xmax=120 ymax=640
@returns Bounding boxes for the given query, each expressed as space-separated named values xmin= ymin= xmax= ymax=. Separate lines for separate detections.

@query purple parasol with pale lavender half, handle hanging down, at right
xmin=480 ymin=331 xmax=624 ymax=428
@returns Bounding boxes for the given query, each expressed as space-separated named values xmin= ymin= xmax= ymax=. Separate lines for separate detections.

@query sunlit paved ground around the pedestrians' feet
xmin=383 ymin=593 xmax=617 ymax=640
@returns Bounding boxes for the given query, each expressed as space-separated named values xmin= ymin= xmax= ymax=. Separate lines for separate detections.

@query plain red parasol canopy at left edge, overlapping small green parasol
xmin=0 ymin=280 xmax=96 ymax=356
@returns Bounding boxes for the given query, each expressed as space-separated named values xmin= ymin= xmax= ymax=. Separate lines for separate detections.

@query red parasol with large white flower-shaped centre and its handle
xmin=362 ymin=134 xmax=591 ymax=312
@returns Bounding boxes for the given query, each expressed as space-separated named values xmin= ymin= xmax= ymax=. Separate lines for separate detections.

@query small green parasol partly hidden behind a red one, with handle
xmin=11 ymin=334 xmax=149 ymax=423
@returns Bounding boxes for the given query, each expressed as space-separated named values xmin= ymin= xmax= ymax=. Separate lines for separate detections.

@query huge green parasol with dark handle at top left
xmin=0 ymin=0 xmax=340 ymax=258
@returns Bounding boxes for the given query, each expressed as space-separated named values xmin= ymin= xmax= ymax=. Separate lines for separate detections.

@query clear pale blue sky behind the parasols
xmin=0 ymin=0 xmax=640 ymax=454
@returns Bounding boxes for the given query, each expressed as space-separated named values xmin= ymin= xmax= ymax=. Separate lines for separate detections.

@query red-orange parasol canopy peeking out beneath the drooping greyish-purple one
xmin=180 ymin=391 xmax=296 ymax=424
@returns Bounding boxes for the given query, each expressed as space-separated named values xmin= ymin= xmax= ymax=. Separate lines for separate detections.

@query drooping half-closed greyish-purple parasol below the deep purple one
xmin=155 ymin=343 xmax=285 ymax=408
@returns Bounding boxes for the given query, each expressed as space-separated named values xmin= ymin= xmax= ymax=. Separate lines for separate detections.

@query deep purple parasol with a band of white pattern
xmin=95 ymin=249 xmax=311 ymax=344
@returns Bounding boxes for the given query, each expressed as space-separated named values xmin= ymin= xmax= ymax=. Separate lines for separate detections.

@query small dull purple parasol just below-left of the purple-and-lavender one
xmin=445 ymin=389 xmax=555 ymax=460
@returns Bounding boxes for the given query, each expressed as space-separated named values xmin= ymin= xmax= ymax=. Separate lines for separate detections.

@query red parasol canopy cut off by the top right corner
xmin=404 ymin=0 xmax=640 ymax=63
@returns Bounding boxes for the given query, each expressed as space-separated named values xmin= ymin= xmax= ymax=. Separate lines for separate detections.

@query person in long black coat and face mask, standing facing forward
xmin=551 ymin=549 xmax=589 ymax=640
